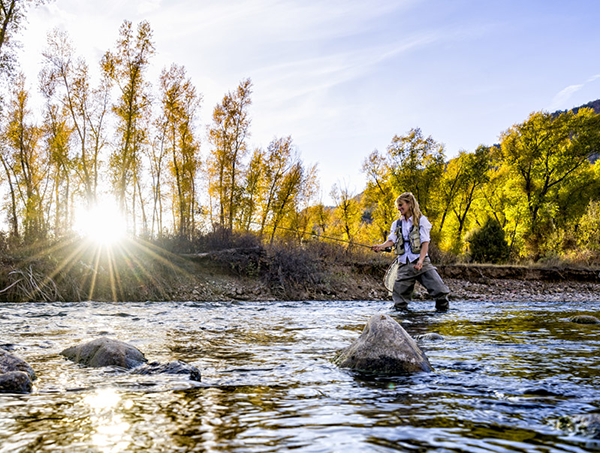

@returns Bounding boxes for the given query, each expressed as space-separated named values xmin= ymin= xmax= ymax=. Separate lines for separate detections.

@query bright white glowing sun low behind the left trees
xmin=75 ymin=202 xmax=127 ymax=245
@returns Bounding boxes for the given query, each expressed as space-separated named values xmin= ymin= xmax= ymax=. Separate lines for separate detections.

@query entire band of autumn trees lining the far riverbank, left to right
xmin=0 ymin=21 xmax=600 ymax=261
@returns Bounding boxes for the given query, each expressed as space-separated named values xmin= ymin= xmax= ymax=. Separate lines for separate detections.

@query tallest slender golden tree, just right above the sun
xmin=102 ymin=21 xmax=154 ymax=232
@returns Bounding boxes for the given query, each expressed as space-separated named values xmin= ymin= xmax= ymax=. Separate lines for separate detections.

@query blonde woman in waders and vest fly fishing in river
xmin=371 ymin=192 xmax=450 ymax=311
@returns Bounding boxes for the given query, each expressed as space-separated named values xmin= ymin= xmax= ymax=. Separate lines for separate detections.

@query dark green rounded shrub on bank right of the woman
xmin=467 ymin=218 xmax=510 ymax=264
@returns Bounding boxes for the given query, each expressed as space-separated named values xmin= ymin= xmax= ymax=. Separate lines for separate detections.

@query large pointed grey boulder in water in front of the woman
xmin=333 ymin=315 xmax=433 ymax=375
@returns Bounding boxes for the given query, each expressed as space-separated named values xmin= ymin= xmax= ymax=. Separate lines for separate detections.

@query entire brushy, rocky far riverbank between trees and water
xmin=0 ymin=241 xmax=600 ymax=302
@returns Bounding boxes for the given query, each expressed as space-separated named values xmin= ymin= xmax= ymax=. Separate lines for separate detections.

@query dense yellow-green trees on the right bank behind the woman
xmin=354 ymin=108 xmax=600 ymax=263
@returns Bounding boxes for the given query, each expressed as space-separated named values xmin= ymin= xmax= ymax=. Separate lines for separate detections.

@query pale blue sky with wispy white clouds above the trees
xmin=21 ymin=0 xmax=600 ymax=201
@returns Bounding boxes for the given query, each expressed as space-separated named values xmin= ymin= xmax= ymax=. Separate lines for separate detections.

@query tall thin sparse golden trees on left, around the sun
xmin=0 ymin=21 xmax=317 ymax=242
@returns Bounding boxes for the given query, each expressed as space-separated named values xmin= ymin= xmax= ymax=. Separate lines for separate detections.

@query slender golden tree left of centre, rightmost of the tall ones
xmin=208 ymin=79 xmax=252 ymax=229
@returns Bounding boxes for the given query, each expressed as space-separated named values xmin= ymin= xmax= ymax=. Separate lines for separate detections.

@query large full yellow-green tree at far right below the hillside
xmin=501 ymin=109 xmax=600 ymax=256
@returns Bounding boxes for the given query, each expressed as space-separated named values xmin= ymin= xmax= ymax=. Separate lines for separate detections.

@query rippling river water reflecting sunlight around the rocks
xmin=0 ymin=301 xmax=600 ymax=453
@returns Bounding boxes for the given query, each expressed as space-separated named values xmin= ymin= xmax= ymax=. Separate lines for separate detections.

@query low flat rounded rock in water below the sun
xmin=61 ymin=338 xmax=148 ymax=369
